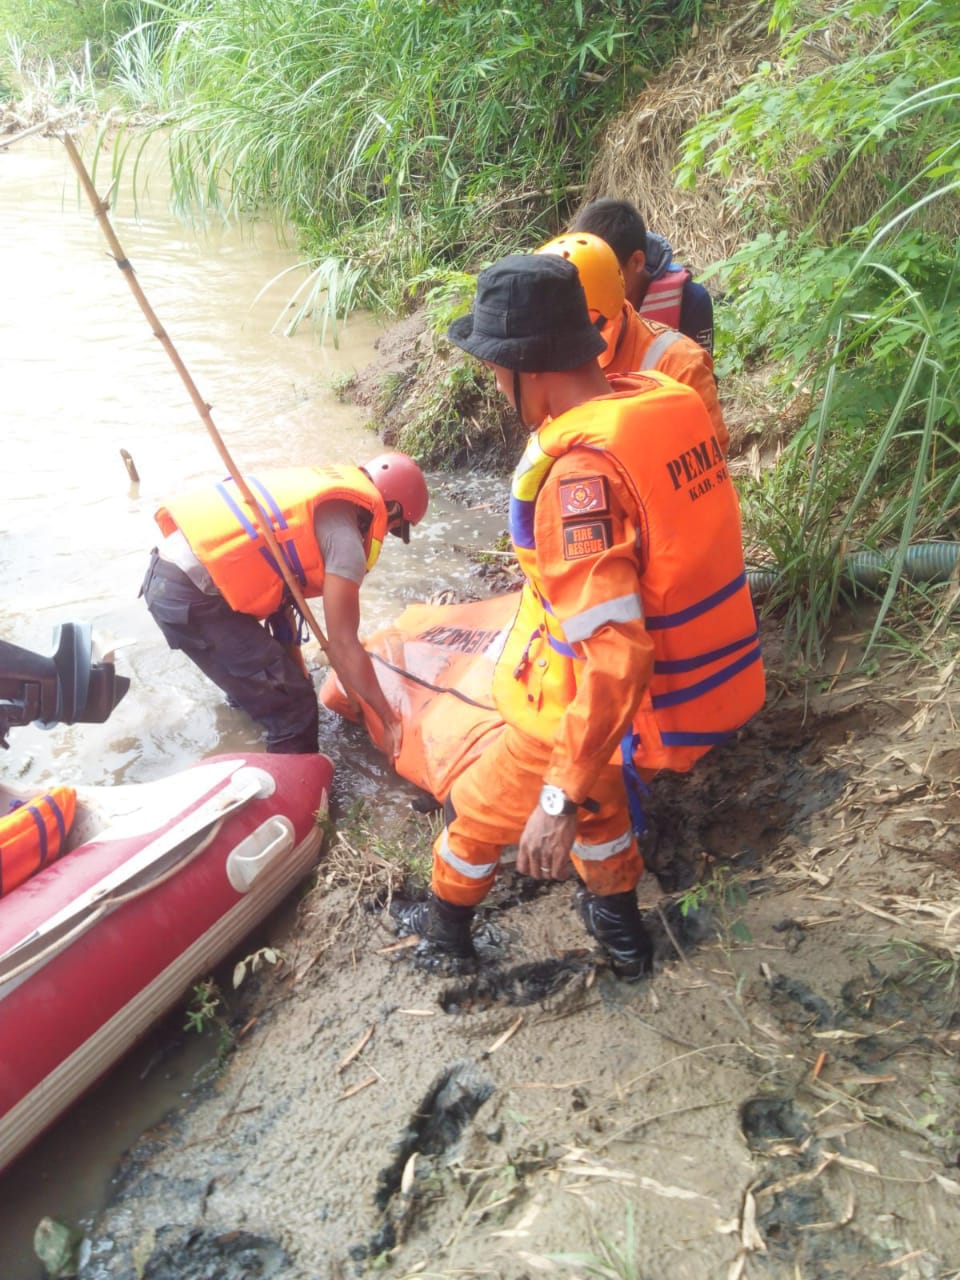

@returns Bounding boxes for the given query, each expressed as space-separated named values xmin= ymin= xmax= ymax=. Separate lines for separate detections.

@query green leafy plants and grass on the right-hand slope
xmin=681 ymin=0 xmax=960 ymax=660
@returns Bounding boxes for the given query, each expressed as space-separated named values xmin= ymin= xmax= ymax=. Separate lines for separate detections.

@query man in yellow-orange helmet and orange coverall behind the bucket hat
xmin=536 ymin=232 xmax=730 ymax=453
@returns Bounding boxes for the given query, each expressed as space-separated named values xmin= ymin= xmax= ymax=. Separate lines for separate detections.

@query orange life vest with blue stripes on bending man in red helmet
xmin=154 ymin=466 xmax=387 ymax=618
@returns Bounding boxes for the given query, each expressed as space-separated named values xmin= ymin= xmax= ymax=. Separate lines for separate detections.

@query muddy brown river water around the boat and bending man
xmin=0 ymin=138 xmax=499 ymax=1280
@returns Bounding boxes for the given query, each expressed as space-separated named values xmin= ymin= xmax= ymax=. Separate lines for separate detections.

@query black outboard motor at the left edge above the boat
xmin=0 ymin=622 xmax=131 ymax=746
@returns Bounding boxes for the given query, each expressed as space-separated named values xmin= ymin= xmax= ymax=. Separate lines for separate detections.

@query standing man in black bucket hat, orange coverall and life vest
xmin=394 ymin=253 xmax=764 ymax=979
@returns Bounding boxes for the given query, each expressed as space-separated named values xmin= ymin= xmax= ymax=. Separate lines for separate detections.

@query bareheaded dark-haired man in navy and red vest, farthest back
xmin=570 ymin=196 xmax=713 ymax=357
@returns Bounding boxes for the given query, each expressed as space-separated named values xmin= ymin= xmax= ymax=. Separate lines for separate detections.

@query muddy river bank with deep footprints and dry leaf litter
xmin=33 ymin=611 xmax=960 ymax=1280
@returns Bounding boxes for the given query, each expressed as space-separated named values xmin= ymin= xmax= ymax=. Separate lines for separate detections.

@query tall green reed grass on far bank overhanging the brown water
xmin=104 ymin=0 xmax=700 ymax=306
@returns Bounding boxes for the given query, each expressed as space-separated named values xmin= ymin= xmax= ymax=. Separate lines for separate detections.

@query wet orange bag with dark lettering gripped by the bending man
xmin=320 ymin=591 xmax=520 ymax=800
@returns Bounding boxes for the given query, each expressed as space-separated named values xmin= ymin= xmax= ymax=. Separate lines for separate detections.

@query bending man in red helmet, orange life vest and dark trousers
xmin=141 ymin=452 xmax=428 ymax=759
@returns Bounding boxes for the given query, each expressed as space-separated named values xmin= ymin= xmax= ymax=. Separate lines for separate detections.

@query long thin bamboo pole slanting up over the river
xmin=60 ymin=133 xmax=328 ymax=653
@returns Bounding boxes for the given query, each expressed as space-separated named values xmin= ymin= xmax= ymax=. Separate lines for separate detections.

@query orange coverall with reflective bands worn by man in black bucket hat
xmin=433 ymin=449 xmax=653 ymax=906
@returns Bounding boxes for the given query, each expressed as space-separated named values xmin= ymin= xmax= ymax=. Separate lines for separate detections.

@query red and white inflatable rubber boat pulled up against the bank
xmin=0 ymin=753 xmax=333 ymax=1169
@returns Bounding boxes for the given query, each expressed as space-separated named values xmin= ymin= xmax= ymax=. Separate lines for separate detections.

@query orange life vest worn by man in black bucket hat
xmin=494 ymin=374 xmax=764 ymax=771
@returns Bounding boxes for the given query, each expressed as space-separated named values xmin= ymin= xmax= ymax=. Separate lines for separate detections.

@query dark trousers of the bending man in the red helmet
xmin=140 ymin=552 xmax=320 ymax=753
